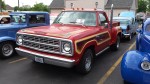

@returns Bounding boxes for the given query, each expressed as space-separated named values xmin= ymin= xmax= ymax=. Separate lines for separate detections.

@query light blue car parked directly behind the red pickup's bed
xmin=113 ymin=17 xmax=137 ymax=40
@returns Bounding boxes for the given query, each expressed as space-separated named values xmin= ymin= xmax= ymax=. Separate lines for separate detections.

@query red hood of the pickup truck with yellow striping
xmin=20 ymin=25 xmax=90 ymax=39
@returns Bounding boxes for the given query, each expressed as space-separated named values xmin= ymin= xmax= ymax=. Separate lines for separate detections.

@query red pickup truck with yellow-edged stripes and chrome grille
xmin=16 ymin=9 xmax=121 ymax=74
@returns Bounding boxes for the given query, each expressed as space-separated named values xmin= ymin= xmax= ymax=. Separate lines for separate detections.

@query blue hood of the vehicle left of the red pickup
xmin=0 ymin=24 xmax=27 ymax=29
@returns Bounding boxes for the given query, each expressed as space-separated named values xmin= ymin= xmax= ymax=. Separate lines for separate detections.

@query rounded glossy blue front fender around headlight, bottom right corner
xmin=121 ymin=51 xmax=150 ymax=84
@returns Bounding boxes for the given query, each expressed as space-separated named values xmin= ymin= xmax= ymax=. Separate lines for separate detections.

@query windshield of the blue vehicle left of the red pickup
xmin=11 ymin=15 xmax=26 ymax=23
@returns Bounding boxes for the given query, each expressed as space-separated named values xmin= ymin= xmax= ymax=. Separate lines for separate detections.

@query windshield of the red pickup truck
xmin=54 ymin=12 xmax=96 ymax=26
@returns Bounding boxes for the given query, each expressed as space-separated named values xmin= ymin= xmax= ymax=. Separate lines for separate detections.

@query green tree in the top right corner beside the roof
xmin=137 ymin=0 xmax=147 ymax=12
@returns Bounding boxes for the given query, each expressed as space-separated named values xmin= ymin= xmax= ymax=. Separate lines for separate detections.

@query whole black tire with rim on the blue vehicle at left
xmin=0 ymin=42 xmax=15 ymax=58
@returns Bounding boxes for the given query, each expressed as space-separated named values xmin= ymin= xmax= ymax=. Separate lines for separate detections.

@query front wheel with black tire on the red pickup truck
xmin=75 ymin=49 xmax=93 ymax=74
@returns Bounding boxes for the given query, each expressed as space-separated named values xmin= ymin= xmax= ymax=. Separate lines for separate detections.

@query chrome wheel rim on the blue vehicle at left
xmin=2 ymin=44 xmax=13 ymax=57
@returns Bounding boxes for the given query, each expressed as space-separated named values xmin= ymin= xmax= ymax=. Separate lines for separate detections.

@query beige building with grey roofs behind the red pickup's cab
xmin=50 ymin=0 xmax=138 ymax=16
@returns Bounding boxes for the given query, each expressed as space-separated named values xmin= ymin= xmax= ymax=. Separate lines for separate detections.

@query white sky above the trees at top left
xmin=3 ymin=0 xmax=52 ymax=7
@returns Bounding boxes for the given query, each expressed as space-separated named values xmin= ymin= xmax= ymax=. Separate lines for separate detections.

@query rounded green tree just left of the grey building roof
xmin=32 ymin=3 xmax=50 ymax=12
